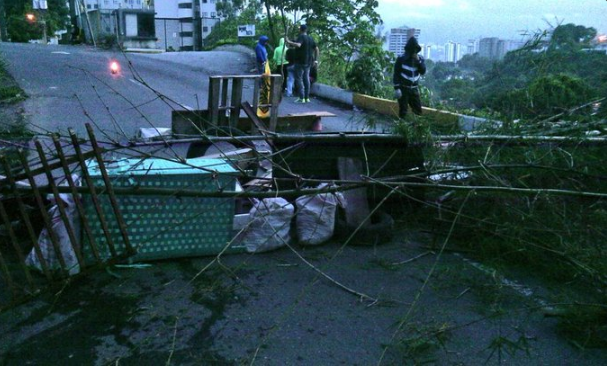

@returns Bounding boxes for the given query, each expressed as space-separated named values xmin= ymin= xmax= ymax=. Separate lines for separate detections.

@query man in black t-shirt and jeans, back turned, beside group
xmin=287 ymin=24 xmax=320 ymax=103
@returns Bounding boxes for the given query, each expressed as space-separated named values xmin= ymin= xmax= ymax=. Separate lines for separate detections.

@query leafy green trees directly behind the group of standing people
xmin=206 ymin=0 xmax=391 ymax=95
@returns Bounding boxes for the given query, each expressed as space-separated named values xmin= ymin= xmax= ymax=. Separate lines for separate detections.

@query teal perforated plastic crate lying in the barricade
xmin=83 ymin=158 xmax=244 ymax=261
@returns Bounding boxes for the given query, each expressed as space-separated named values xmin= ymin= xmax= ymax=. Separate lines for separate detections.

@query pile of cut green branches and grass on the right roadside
xmin=418 ymin=143 xmax=607 ymax=347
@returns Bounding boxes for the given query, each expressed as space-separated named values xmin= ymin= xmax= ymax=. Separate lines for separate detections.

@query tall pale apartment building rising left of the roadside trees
xmin=155 ymin=0 xmax=221 ymax=51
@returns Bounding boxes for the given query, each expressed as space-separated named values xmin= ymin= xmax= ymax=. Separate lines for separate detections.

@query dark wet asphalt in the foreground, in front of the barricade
xmin=0 ymin=226 xmax=605 ymax=365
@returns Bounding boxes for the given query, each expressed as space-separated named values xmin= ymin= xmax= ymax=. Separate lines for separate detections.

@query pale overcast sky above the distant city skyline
xmin=377 ymin=0 xmax=607 ymax=44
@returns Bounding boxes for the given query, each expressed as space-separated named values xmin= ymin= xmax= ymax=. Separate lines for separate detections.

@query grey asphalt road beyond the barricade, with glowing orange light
xmin=0 ymin=43 xmax=364 ymax=140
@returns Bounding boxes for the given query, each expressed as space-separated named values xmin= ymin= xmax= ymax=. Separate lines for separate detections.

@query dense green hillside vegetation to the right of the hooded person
xmin=427 ymin=24 xmax=607 ymax=120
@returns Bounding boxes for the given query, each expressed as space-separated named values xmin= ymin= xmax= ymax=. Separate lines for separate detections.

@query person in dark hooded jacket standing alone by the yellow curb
xmin=392 ymin=37 xmax=426 ymax=118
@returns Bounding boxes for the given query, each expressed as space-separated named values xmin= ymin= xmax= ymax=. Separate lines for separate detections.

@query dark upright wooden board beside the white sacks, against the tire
xmin=337 ymin=157 xmax=371 ymax=228
